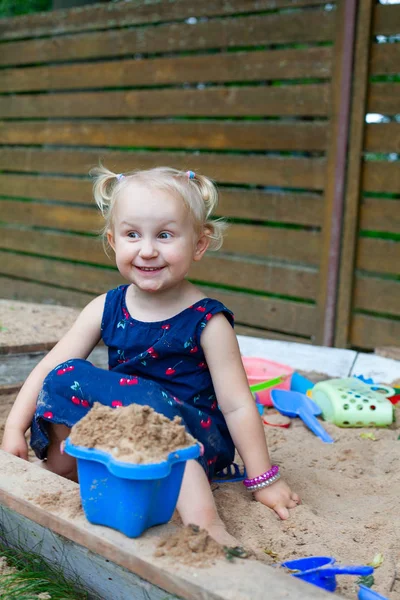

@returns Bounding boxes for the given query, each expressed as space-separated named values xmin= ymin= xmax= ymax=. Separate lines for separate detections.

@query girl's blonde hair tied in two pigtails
xmin=90 ymin=164 xmax=228 ymax=250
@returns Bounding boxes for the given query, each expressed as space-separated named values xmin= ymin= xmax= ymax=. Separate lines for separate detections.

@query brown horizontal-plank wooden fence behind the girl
xmin=0 ymin=0 xmax=400 ymax=348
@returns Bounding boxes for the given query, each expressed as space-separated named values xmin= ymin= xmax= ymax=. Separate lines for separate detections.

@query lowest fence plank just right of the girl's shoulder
xmin=200 ymin=286 xmax=316 ymax=336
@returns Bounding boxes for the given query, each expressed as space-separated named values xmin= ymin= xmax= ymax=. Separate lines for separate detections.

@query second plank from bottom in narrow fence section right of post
xmin=354 ymin=274 xmax=400 ymax=315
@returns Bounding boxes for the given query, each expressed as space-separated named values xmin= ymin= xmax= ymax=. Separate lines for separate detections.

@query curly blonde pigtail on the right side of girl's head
xmin=188 ymin=171 xmax=228 ymax=250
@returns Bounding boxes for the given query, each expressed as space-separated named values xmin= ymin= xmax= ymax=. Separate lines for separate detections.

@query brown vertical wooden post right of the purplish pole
xmin=334 ymin=0 xmax=374 ymax=347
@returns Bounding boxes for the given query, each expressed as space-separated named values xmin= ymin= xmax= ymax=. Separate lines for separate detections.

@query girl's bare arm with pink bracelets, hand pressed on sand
xmin=201 ymin=314 xmax=299 ymax=519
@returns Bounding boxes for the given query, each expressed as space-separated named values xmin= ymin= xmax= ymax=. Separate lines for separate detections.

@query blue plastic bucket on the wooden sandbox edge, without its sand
xmin=65 ymin=438 xmax=200 ymax=537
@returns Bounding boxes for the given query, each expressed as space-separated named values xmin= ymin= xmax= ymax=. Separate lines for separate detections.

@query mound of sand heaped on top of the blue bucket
xmin=70 ymin=402 xmax=196 ymax=464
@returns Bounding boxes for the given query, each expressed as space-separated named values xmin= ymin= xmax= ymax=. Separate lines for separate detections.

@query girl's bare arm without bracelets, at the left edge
xmin=3 ymin=294 xmax=105 ymax=442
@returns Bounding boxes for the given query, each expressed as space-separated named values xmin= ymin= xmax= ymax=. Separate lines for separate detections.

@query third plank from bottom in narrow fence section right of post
xmin=356 ymin=237 xmax=400 ymax=275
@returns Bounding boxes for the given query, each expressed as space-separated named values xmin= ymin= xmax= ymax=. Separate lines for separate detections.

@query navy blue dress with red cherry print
xmin=31 ymin=285 xmax=238 ymax=479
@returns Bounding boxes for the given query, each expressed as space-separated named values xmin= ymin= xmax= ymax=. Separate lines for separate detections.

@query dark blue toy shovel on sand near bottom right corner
xmin=282 ymin=556 xmax=374 ymax=592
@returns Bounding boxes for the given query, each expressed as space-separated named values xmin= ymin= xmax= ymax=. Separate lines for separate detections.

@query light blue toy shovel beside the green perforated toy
xmin=271 ymin=390 xmax=334 ymax=444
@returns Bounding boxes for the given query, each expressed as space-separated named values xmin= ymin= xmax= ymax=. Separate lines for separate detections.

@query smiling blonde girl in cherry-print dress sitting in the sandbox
xmin=3 ymin=167 xmax=299 ymax=546
